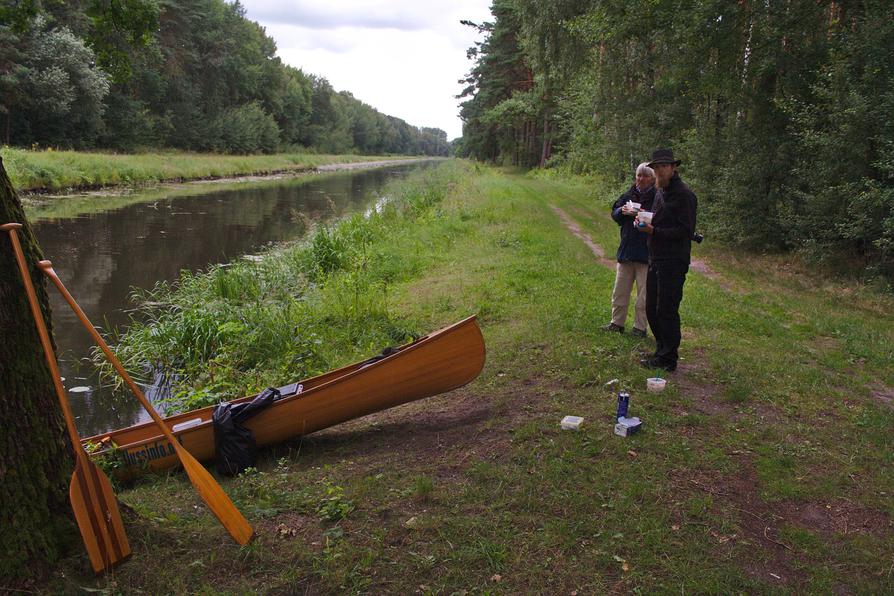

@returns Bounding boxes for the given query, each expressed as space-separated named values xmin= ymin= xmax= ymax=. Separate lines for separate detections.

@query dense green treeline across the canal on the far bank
xmin=0 ymin=0 xmax=447 ymax=155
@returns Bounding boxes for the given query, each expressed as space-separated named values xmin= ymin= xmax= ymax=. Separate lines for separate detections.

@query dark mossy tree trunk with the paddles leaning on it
xmin=0 ymin=158 xmax=75 ymax=591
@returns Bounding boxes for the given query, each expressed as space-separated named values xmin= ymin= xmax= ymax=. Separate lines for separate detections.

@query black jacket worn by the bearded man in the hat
xmin=649 ymin=172 xmax=698 ymax=263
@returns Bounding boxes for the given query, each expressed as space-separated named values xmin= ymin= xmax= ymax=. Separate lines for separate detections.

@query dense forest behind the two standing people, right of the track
xmin=458 ymin=0 xmax=894 ymax=276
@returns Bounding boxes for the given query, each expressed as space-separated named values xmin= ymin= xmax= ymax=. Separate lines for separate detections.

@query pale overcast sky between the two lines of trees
xmin=242 ymin=0 xmax=491 ymax=139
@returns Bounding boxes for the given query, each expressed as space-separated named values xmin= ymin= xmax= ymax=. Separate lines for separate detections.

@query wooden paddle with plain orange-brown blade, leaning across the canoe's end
xmin=37 ymin=261 xmax=254 ymax=544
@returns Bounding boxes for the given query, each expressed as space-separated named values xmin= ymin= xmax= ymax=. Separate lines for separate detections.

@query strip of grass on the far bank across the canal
xmin=0 ymin=147 xmax=414 ymax=192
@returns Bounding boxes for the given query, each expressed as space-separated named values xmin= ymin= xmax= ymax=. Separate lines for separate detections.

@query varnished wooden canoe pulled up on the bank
xmin=83 ymin=316 xmax=485 ymax=476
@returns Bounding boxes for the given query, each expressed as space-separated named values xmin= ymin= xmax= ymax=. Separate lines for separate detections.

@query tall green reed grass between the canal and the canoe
xmin=104 ymin=162 xmax=468 ymax=412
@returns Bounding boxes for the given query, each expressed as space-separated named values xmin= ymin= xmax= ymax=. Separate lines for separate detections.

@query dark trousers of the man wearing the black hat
xmin=646 ymin=259 xmax=689 ymax=366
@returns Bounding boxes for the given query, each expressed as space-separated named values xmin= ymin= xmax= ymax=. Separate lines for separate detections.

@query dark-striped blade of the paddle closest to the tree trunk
xmin=68 ymin=457 xmax=130 ymax=573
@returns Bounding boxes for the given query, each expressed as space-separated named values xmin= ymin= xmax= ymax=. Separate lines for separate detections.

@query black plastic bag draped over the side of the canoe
xmin=211 ymin=387 xmax=280 ymax=476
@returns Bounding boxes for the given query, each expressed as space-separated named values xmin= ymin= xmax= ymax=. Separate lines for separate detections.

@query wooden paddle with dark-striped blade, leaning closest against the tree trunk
xmin=0 ymin=223 xmax=130 ymax=573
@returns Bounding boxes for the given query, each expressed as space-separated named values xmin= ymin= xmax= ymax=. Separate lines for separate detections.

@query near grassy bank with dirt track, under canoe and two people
xmin=35 ymin=163 xmax=894 ymax=594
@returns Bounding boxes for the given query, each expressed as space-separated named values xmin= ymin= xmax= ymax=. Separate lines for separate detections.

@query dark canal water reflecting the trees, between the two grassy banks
xmin=29 ymin=162 xmax=440 ymax=437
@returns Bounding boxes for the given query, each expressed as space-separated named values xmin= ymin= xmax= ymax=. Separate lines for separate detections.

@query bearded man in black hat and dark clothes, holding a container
xmin=639 ymin=149 xmax=698 ymax=371
